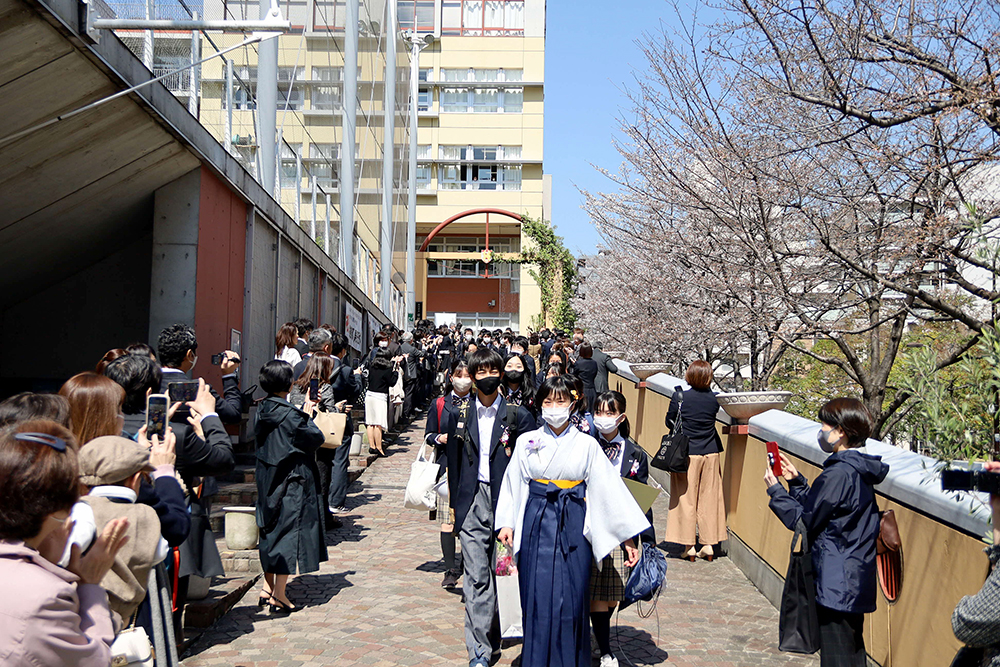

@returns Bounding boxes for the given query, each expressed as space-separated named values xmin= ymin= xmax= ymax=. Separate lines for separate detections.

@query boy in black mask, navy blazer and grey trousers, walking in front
xmin=445 ymin=349 xmax=535 ymax=667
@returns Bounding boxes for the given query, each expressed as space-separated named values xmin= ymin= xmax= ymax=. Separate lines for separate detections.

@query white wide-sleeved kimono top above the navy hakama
xmin=493 ymin=425 xmax=649 ymax=563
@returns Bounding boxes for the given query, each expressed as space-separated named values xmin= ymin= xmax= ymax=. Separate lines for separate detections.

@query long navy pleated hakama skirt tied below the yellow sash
xmin=518 ymin=480 xmax=593 ymax=667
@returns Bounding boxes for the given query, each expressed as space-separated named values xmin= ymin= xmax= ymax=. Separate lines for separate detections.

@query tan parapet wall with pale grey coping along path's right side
xmin=609 ymin=364 xmax=989 ymax=667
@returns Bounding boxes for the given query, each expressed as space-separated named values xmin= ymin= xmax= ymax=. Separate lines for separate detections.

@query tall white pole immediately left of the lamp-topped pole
xmin=379 ymin=1 xmax=396 ymax=317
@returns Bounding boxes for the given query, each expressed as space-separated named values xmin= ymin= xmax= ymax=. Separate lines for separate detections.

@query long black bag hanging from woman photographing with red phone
xmin=778 ymin=519 xmax=819 ymax=653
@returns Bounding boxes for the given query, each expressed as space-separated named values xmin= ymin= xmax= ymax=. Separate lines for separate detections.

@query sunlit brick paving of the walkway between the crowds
xmin=183 ymin=421 xmax=819 ymax=667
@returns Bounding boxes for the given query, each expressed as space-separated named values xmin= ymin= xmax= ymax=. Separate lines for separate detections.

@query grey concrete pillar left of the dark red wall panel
xmin=149 ymin=168 xmax=201 ymax=345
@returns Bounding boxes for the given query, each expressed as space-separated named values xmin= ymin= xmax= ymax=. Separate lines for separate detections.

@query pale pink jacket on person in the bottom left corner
xmin=0 ymin=541 xmax=115 ymax=667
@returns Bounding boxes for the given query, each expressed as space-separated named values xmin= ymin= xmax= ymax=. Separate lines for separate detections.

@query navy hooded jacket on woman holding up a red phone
xmin=767 ymin=449 xmax=889 ymax=613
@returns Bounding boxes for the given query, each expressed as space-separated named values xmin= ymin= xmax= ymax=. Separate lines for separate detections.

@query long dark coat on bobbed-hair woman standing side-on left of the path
xmin=254 ymin=396 xmax=327 ymax=574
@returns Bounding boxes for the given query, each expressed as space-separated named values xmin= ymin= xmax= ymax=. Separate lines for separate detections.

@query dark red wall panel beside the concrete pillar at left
xmin=194 ymin=167 xmax=247 ymax=390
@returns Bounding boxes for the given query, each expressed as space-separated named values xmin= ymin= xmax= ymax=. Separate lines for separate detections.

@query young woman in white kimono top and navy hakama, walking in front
xmin=494 ymin=375 xmax=650 ymax=667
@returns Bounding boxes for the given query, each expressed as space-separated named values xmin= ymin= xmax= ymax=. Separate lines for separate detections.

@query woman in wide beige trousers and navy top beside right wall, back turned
xmin=666 ymin=360 xmax=727 ymax=560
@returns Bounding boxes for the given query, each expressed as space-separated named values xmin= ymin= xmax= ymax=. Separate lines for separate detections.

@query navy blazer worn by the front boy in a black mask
xmin=445 ymin=395 xmax=535 ymax=532
